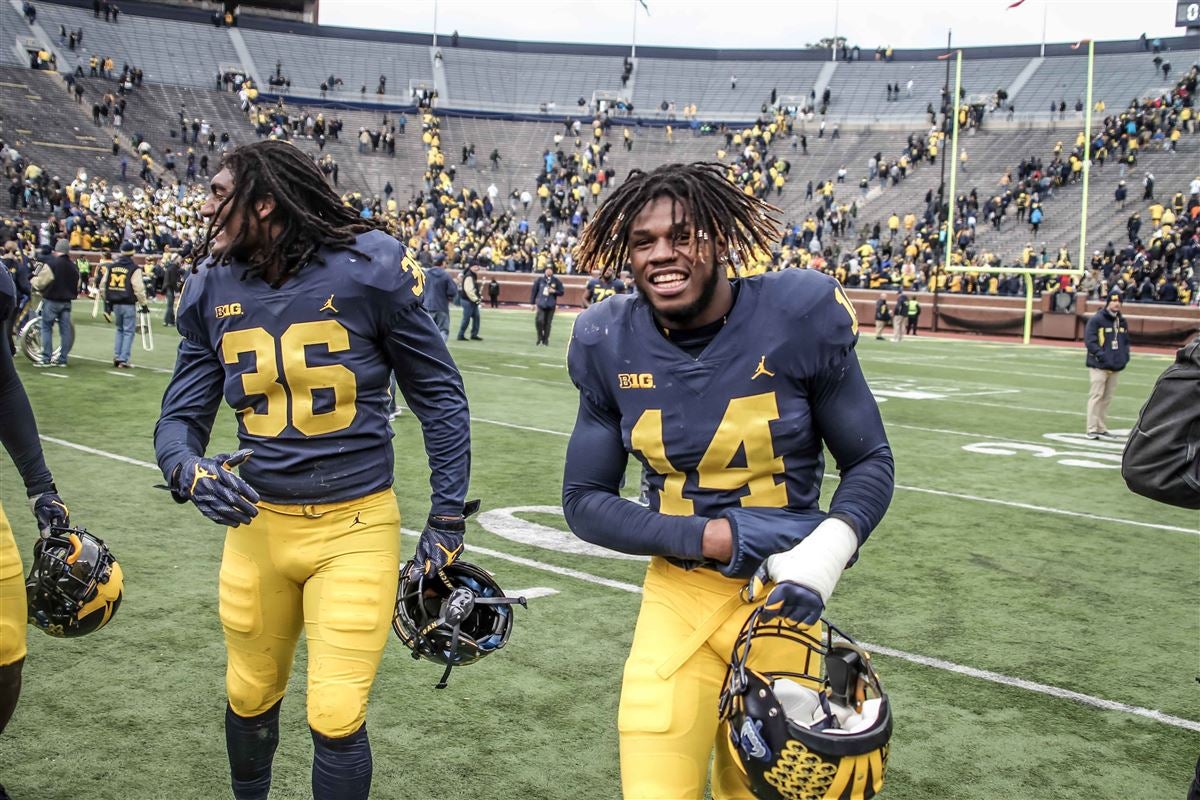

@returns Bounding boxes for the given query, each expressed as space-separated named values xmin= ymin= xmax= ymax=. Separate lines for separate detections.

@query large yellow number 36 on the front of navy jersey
xmin=221 ymin=319 xmax=358 ymax=438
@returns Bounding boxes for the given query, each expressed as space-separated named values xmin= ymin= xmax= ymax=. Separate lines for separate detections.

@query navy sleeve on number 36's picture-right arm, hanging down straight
xmin=385 ymin=302 xmax=470 ymax=515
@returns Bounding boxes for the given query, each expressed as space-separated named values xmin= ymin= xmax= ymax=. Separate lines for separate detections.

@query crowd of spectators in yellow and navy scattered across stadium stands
xmin=0 ymin=10 xmax=1200 ymax=302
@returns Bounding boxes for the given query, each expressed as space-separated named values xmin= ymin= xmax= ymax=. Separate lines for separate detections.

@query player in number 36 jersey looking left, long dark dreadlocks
xmin=155 ymin=140 xmax=479 ymax=800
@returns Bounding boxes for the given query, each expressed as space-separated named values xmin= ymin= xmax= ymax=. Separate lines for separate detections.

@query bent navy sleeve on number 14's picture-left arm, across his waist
xmin=563 ymin=391 xmax=708 ymax=561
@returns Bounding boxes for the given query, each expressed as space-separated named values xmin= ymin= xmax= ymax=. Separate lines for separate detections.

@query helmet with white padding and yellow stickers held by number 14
xmin=719 ymin=608 xmax=892 ymax=800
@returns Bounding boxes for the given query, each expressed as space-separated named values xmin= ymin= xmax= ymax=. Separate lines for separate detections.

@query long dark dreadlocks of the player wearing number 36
xmin=192 ymin=139 xmax=379 ymax=284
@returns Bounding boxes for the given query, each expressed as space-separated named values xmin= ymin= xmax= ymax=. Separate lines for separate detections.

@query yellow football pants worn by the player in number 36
xmin=221 ymin=489 xmax=400 ymax=738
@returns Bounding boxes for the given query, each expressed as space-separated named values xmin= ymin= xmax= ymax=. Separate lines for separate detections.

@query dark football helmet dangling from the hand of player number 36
xmin=391 ymin=561 xmax=528 ymax=688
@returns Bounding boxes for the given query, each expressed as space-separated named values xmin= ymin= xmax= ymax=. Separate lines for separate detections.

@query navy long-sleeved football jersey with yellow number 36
xmin=155 ymin=231 xmax=470 ymax=513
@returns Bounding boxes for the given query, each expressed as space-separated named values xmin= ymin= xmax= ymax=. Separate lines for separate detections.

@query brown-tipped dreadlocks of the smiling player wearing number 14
xmin=575 ymin=162 xmax=780 ymax=272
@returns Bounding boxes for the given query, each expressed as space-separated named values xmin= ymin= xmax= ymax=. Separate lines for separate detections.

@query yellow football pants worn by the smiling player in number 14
xmin=617 ymin=558 xmax=821 ymax=800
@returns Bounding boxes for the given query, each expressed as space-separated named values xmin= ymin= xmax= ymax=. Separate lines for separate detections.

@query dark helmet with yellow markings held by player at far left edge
xmin=25 ymin=527 xmax=125 ymax=637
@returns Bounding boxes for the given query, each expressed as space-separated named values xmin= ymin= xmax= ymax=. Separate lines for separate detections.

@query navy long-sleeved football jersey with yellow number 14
xmin=564 ymin=270 xmax=892 ymax=559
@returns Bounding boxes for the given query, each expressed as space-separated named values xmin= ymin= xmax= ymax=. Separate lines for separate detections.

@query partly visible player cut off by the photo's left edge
xmin=0 ymin=269 xmax=71 ymax=798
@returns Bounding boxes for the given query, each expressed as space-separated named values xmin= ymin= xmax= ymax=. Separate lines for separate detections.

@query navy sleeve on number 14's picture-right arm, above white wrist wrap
xmin=809 ymin=351 xmax=895 ymax=545
